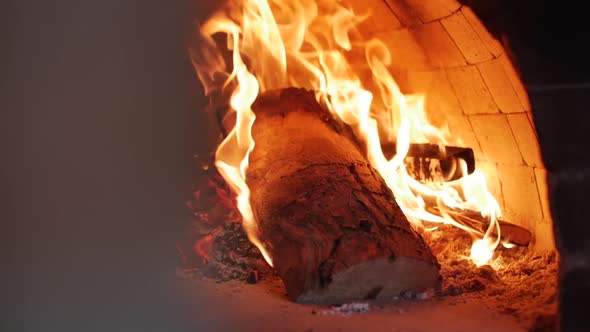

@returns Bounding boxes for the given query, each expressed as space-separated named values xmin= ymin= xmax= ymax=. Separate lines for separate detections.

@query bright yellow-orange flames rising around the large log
xmin=193 ymin=0 xmax=501 ymax=265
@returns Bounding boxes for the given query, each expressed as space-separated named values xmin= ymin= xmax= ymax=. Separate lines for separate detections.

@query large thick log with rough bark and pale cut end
xmin=247 ymin=88 xmax=440 ymax=303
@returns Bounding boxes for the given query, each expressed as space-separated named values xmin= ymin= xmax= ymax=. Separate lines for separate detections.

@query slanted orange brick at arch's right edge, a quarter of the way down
xmin=477 ymin=60 xmax=524 ymax=113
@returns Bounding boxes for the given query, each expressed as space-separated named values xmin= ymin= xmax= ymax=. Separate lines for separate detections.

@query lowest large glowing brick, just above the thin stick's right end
xmin=498 ymin=164 xmax=543 ymax=232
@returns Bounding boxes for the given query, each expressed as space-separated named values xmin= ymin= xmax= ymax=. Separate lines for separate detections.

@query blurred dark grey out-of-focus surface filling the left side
xmin=0 ymin=0 xmax=218 ymax=332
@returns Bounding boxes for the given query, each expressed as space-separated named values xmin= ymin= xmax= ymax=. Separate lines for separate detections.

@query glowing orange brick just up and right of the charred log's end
xmin=469 ymin=114 xmax=524 ymax=165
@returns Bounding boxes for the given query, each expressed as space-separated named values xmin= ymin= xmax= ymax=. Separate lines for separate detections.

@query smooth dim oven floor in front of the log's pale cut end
xmin=179 ymin=276 xmax=531 ymax=332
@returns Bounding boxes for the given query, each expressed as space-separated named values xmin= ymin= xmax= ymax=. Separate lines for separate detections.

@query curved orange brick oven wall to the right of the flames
xmin=347 ymin=0 xmax=555 ymax=250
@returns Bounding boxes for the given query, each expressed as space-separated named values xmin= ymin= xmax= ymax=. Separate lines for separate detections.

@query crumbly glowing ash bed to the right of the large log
xmin=423 ymin=226 xmax=558 ymax=321
